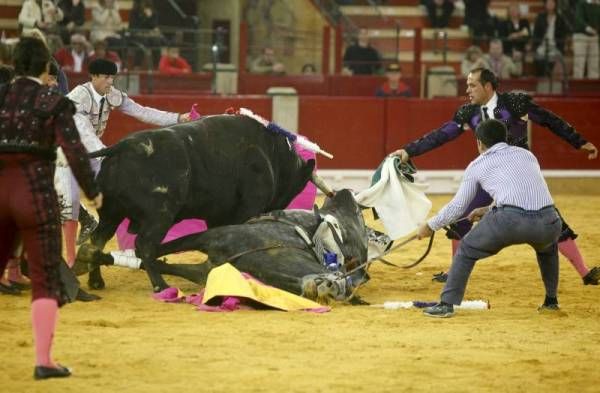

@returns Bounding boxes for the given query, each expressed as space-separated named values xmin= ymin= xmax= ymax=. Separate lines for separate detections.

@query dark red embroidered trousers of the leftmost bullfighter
xmin=0 ymin=154 xmax=65 ymax=304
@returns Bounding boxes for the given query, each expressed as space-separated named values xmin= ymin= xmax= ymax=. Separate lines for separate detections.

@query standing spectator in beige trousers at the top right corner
xmin=573 ymin=0 xmax=600 ymax=79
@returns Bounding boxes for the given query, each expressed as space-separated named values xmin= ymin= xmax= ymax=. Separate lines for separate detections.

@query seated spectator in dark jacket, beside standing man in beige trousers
xmin=533 ymin=0 xmax=569 ymax=76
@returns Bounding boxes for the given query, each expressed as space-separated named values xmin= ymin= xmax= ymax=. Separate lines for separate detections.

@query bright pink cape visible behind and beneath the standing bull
xmin=116 ymin=144 xmax=317 ymax=250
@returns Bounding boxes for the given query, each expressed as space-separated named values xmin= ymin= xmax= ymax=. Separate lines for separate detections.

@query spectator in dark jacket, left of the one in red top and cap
xmin=344 ymin=29 xmax=381 ymax=75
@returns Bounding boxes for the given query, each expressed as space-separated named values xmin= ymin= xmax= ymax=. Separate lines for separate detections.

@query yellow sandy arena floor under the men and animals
xmin=0 ymin=195 xmax=600 ymax=393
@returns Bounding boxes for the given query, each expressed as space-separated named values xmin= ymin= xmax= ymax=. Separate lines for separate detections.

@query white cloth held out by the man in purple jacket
xmin=355 ymin=157 xmax=431 ymax=240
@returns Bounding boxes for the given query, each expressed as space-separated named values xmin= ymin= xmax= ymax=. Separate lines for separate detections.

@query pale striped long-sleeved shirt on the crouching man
xmin=427 ymin=143 xmax=554 ymax=231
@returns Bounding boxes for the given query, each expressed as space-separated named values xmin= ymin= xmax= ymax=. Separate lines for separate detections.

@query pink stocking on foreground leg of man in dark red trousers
xmin=31 ymin=298 xmax=58 ymax=367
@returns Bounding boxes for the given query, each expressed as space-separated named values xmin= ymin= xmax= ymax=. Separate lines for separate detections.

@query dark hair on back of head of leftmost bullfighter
xmin=13 ymin=37 xmax=50 ymax=77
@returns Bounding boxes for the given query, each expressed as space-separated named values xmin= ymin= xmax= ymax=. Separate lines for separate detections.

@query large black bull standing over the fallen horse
xmin=84 ymin=115 xmax=322 ymax=291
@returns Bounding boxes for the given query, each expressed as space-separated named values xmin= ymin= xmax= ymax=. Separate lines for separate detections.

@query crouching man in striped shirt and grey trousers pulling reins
xmin=417 ymin=119 xmax=562 ymax=318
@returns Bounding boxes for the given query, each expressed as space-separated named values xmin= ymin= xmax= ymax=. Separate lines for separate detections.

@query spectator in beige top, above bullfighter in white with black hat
xmin=90 ymin=0 xmax=123 ymax=47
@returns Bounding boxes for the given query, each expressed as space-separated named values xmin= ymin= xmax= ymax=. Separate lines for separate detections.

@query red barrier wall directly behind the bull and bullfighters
xmin=104 ymin=95 xmax=600 ymax=169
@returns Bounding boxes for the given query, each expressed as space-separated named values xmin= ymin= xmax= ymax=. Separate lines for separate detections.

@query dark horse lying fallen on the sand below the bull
xmin=74 ymin=190 xmax=368 ymax=301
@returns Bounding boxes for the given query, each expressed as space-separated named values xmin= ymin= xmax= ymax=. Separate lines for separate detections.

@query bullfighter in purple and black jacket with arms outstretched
xmin=392 ymin=68 xmax=600 ymax=285
